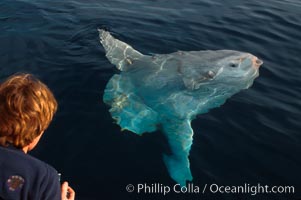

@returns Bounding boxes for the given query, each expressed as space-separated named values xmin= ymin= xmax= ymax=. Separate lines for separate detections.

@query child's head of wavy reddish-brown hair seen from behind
xmin=0 ymin=74 xmax=57 ymax=149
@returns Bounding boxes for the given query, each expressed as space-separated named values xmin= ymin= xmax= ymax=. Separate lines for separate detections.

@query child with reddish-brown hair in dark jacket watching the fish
xmin=0 ymin=74 xmax=75 ymax=200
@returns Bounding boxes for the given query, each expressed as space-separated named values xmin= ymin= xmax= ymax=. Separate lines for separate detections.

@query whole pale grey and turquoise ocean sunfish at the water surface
xmin=99 ymin=30 xmax=262 ymax=186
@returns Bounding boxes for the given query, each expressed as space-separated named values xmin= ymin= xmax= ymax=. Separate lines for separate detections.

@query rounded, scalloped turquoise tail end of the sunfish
xmin=103 ymin=74 xmax=158 ymax=135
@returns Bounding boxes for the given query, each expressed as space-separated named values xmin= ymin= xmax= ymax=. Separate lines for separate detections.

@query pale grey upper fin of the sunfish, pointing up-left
xmin=98 ymin=29 xmax=143 ymax=71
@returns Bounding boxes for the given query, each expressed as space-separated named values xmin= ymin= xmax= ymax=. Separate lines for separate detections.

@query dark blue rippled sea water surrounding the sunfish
xmin=0 ymin=0 xmax=301 ymax=200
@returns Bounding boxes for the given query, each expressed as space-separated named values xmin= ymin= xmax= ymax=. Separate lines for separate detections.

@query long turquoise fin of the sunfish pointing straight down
xmin=162 ymin=120 xmax=193 ymax=186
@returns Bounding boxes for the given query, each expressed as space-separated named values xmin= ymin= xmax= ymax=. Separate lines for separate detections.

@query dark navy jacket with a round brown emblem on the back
xmin=0 ymin=146 xmax=61 ymax=200
